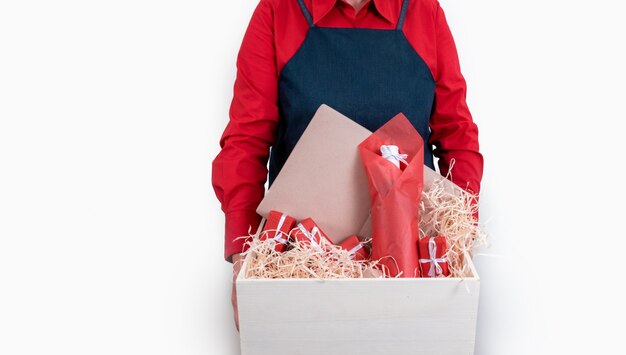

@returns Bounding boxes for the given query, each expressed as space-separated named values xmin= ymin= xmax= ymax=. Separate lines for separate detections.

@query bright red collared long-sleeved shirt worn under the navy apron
xmin=212 ymin=0 xmax=483 ymax=261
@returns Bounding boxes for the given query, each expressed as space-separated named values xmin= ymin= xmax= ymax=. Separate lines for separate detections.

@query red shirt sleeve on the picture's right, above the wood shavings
xmin=429 ymin=4 xmax=483 ymax=218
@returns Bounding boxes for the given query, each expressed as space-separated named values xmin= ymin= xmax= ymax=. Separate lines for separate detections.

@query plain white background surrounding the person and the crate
xmin=0 ymin=0 xmax=626 ymax=355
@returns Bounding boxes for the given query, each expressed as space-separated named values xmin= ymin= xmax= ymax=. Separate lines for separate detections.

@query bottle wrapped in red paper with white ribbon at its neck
xmin=359 ymin=113 xmax=424 ymax=277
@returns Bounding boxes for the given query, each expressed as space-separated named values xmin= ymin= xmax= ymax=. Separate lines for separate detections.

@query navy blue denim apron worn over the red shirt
xmin=269 ymin=0 xmax=435 ymax=185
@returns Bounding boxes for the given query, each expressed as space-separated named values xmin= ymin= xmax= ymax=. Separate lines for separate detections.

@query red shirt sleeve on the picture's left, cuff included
xmin=212 ymin=0 xmax=278 ymax=261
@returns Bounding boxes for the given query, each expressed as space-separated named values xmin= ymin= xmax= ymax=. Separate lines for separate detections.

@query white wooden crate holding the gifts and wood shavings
xmin=236 ymin=224 xmax=480 ymax=355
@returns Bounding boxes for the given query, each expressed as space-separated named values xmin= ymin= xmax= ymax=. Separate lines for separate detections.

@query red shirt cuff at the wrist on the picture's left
xmin=224 ymin=210 xmax=261 ymax=263
